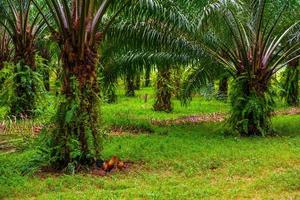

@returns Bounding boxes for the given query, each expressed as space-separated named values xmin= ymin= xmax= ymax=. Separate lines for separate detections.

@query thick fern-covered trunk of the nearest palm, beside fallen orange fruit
xmin=51 ymin=45 xmax=102 ymax=168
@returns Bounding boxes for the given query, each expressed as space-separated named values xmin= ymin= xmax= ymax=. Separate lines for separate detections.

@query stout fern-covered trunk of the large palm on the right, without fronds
xmin=228 ymin=77 xmax=274 ymax=137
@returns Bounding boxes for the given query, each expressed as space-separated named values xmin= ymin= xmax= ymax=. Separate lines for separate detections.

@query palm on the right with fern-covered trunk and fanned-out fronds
xmin=197 ymin=0 xmax=298 ymax=136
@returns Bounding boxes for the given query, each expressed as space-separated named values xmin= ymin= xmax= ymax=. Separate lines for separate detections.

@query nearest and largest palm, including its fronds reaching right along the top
xmin=35 ymin=0 xmax=190 ymax=168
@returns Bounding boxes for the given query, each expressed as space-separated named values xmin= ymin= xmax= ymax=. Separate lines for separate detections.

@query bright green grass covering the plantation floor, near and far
xmin=0 ymin=89 xmax=300 ymax=199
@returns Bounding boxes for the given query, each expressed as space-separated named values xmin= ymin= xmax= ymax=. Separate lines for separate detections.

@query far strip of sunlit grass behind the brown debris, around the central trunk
xmin=102 ymin=88 xmax=229 ymax=123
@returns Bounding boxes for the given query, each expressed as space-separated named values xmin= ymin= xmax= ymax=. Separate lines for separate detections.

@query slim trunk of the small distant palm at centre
xmin=153 ymin=67 xmax=173 ymax=112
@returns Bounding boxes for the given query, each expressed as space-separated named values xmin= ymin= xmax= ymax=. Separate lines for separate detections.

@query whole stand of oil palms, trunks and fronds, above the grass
xmin=0 ymin=0 xmax=300 ymax=169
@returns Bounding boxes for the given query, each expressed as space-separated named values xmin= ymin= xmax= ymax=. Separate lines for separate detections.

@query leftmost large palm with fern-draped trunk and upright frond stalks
xmin=0 ymin=0 xmax=44 ymax=117
